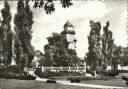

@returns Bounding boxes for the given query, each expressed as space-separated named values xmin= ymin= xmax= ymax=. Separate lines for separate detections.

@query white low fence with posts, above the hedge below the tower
xmin=41 ymin=66 xmax=86 ymax=72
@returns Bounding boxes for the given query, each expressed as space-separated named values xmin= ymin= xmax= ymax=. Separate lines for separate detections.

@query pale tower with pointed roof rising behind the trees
xmin=62 ymin=21 xmax=76 ymax=49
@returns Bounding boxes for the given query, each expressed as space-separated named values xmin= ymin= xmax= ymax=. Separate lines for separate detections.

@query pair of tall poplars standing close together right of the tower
xmin=86 ymin=21 xmax=117 ymax=71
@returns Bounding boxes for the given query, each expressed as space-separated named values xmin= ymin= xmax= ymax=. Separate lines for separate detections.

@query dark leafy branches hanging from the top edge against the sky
xmin=33 ymin=0 xmax=73 ymax=14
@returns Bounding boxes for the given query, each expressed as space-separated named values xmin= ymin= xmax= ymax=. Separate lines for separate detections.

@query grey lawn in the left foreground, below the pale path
xmin=0 ymin=79 xmax=94 ymax=89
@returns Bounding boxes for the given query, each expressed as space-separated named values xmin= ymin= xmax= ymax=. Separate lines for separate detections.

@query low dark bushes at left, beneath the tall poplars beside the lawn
xmin=0 ymin=66 xmax=36 ymax=80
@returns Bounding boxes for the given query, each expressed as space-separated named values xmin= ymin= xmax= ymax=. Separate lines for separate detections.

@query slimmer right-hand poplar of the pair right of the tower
xmin=102 ymin=22 xmax=114 ymax=70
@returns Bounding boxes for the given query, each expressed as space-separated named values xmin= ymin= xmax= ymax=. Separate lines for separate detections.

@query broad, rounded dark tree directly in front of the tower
xmin=44 ymin=33 xmax=78 ymax=66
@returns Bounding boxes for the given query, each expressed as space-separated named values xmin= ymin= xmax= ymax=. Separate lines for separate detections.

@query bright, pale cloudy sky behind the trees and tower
xmin=0 ymin=0 xmax=127 ymax=57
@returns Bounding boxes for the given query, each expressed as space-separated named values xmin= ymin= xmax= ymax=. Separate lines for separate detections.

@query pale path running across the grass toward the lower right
xmin=36 ymin=78 xmax=128 ymax=89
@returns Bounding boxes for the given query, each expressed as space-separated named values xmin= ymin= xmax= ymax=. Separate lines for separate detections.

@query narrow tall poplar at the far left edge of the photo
xmin=0 ymin=0 xmax=13 ymax=66
